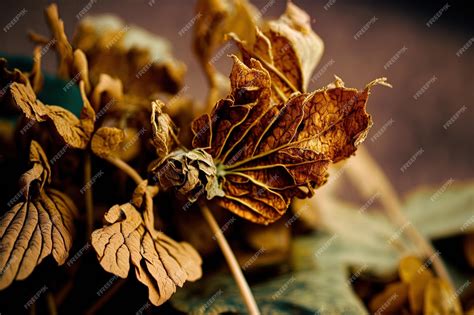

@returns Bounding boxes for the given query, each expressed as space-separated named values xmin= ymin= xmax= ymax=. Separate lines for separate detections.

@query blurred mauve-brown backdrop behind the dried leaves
xmin=0 ymin=0 xmax=474 ymax=194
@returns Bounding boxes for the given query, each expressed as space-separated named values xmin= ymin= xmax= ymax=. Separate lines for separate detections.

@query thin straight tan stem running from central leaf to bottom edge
xmin=201 ymin=204 xmax=260 ymax=314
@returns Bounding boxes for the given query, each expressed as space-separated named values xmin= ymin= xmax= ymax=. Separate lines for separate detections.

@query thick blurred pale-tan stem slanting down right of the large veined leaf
xmin=349 ymin=147 xmax=453 ymax=286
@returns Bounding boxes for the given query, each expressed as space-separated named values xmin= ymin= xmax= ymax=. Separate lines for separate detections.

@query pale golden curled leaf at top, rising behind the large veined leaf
xmin=231 ymin=1 xmax=324 ymax=103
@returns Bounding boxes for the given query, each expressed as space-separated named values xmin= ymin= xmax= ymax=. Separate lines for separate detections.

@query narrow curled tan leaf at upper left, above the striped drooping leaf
xmin=10 ymin=81 xmax=95 ymax=149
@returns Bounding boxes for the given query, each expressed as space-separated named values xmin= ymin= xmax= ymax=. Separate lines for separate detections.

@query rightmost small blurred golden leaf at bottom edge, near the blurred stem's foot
xmin=423 ymin=278 xmax=463 ymax=315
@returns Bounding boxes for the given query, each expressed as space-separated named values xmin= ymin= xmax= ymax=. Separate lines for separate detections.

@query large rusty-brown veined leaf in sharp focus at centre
xmin=192 ymin=56 xmax=387 ymax=224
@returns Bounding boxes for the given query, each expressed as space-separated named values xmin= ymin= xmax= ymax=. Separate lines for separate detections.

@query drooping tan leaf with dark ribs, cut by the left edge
xmin=0 ymin=141 xmax=77 ymax=290
